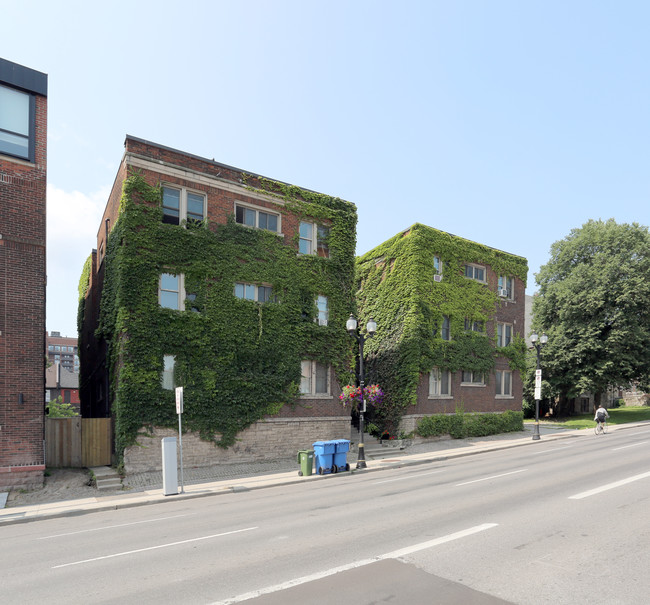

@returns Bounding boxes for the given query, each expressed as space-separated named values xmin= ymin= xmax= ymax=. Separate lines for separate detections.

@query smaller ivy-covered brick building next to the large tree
xmin=357 ymin=223 xmax=528 ymax=433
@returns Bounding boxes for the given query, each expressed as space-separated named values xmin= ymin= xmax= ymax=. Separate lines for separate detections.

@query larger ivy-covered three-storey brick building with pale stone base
xmin=79 ymin=136 xmax=357 ymax=472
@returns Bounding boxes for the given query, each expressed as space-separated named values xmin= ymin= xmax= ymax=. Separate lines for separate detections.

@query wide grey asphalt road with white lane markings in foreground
xmin=0 ymin=427 xmax=650 ymax=605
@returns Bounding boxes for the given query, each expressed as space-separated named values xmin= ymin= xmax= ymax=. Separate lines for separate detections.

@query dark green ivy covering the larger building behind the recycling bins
xmin=96 ymin=173 xmax=357 ymax=456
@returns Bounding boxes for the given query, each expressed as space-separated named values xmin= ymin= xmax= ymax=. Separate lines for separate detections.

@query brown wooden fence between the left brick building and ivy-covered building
xmin=45 ymin=416 xmax=113 ymax=468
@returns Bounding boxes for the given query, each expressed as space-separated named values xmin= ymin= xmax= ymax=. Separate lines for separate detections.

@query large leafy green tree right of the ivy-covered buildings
xmin=533 ymin=219 xmax=650 ymax=412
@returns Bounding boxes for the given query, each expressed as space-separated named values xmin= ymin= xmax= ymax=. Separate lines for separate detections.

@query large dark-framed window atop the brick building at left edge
xmin=0 ymin=85 xmax=36 ymax=162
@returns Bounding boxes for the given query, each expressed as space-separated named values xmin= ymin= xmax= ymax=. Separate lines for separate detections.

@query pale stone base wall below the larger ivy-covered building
xmin=124 ymin=416 xmax=350 ymax=474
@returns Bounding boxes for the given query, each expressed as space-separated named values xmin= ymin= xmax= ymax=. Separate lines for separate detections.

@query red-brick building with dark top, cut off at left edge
xmin=0 ymin=59 xmax=47 ymax=489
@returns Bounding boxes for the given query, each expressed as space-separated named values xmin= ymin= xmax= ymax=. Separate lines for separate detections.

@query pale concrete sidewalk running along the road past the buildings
xmin=0 ymin=423 xmax=636 ymax=525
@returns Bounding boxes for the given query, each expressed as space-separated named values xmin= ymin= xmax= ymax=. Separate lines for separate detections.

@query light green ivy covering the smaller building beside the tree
xmin=357 ymin=223 xmax=528 ymax=430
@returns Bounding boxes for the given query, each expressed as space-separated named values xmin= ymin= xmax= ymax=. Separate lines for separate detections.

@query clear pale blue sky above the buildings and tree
xmin=0 ymin=0 xmax=650 ymax=337
